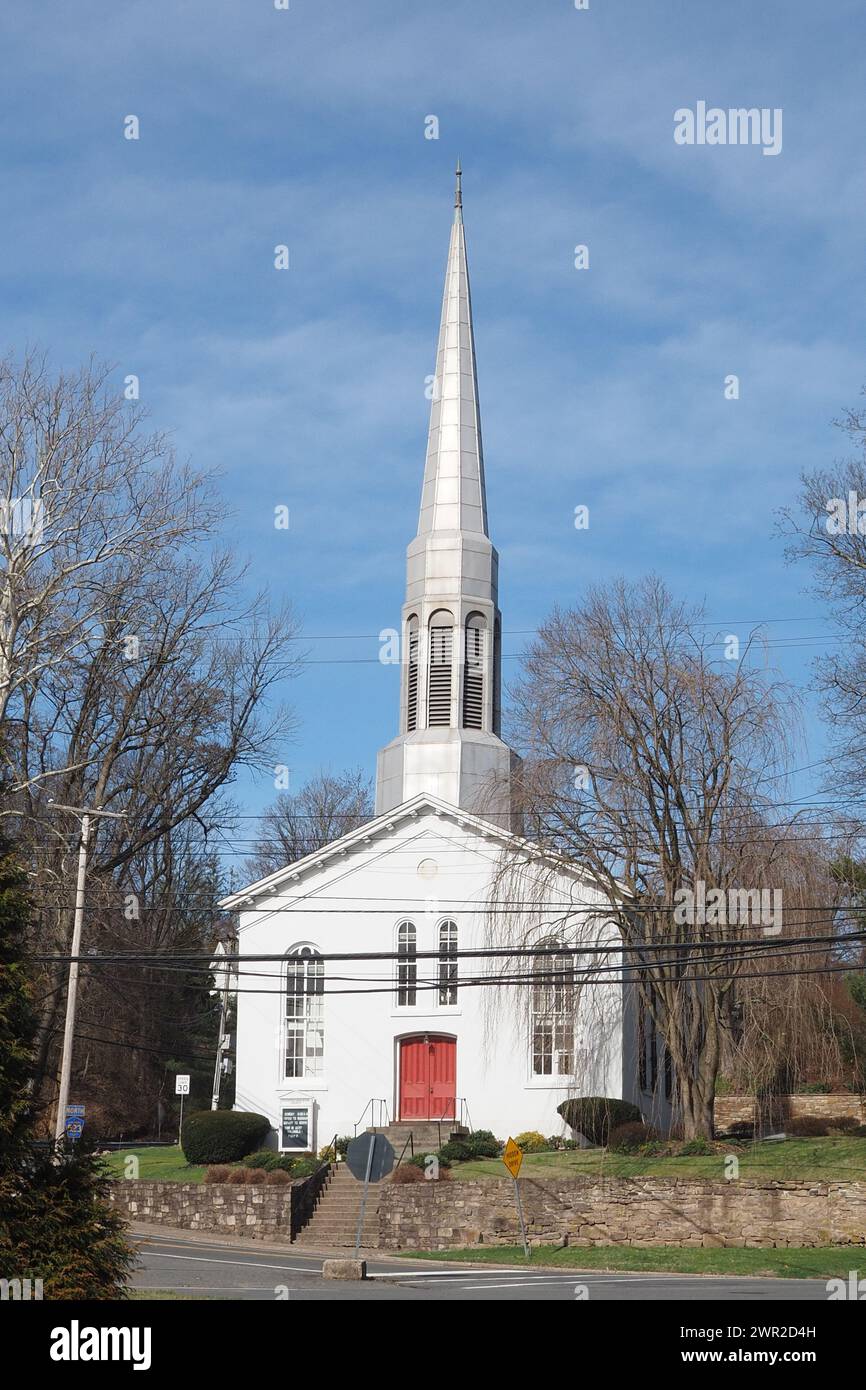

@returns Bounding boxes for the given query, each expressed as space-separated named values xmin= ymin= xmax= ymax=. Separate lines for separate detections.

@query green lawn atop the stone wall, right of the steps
xmin=452 ymin=1138 xmax=866 ymax=1182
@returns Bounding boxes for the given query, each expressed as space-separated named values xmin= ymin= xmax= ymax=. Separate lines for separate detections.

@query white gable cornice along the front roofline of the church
xmin=220 ymin=792 xmax=603 ymax=912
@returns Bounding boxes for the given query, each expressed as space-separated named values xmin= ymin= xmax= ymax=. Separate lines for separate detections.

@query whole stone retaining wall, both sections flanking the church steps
xmin=111 ymin=1167 xmax=866 ymax=1250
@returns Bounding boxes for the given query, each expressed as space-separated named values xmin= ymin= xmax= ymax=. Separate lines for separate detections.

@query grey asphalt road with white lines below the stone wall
xmin=133 ymin=1234 xmax=827 ymax=1302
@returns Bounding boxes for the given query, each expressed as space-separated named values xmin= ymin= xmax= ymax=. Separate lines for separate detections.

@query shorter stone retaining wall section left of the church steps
xmin=111 ymin=1179 xmax=297 ymax=1240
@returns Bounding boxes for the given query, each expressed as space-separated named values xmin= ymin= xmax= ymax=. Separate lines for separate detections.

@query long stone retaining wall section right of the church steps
xmin=379 ymin=1177 xmax=866 ymax=1250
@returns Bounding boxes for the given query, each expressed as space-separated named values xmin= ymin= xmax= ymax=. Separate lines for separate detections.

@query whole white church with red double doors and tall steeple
xmin=222 ymin=171 xmax=655 ymax=1151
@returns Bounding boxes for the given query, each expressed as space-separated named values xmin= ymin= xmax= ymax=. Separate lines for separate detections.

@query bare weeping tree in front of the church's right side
xmin=499 ymin=578 xmax=792 ymax=1137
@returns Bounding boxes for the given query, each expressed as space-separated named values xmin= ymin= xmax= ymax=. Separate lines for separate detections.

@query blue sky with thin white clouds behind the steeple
xmin=0 ymin=0 xmax=866 ymax=867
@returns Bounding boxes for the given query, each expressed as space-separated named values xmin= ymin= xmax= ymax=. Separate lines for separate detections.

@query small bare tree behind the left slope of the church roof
xmin=247 ymin=767 xmax=373 ymax=878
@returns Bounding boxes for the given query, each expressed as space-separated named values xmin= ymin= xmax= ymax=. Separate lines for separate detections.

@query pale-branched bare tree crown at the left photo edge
xmin=0 ymin=353 xmax=222 ymax=772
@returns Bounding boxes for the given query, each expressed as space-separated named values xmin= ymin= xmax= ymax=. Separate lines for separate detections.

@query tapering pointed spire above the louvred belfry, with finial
xmin=418 ymin=160 xmax=488 ymax=535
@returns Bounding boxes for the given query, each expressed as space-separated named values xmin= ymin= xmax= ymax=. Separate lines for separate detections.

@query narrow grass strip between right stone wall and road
xmin=400 ymin=1245 xmax=866 ymax=1279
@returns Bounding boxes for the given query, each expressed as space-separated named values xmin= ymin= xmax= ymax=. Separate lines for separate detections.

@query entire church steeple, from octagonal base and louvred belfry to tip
xmin=377 ymin=172 xmax=514 ymax=826
